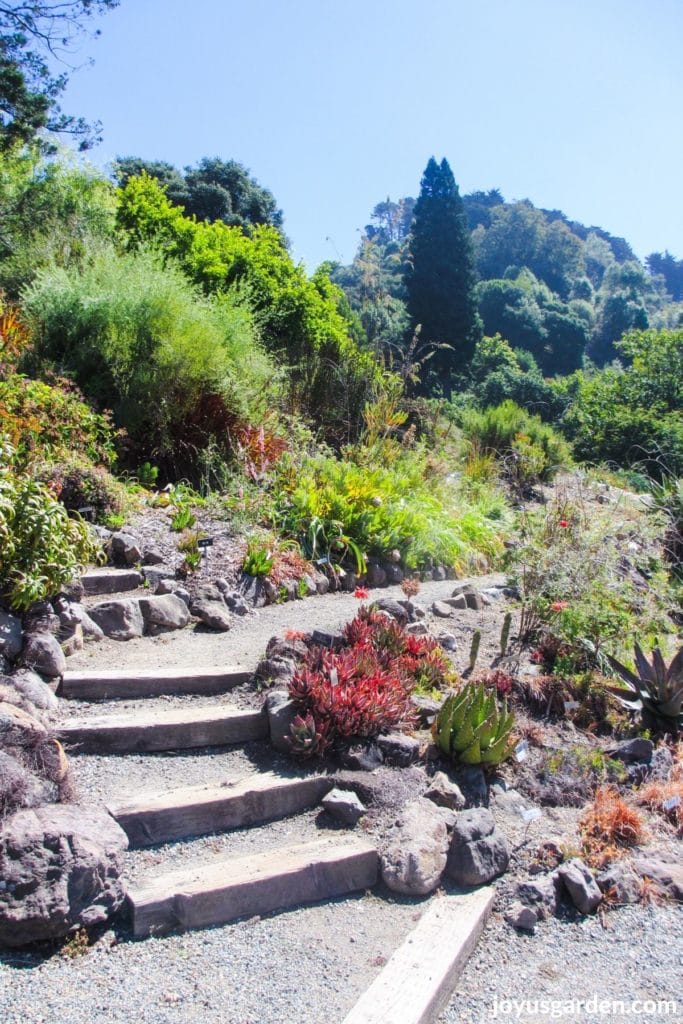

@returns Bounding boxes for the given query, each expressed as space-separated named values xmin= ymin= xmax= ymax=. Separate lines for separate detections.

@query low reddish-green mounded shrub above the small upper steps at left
xmin=32 ymin=456 xmax=127 ymax=523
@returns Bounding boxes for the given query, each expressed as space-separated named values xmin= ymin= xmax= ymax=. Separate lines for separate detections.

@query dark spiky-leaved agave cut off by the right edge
xmin=606 ymin=644 xmax=683 ymax=733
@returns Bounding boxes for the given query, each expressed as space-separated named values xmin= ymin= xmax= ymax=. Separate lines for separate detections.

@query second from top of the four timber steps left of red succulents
xmin=57 ymin=707 xmax=268 ymax=754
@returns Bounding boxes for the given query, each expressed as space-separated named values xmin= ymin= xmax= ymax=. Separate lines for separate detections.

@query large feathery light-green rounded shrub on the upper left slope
xmin=25 ymin=249 xmax=279 ymax=478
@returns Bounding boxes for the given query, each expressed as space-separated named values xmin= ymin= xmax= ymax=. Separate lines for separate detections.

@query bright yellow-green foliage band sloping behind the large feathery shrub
xmin=119 ymin=175 xmax=379 ymax=439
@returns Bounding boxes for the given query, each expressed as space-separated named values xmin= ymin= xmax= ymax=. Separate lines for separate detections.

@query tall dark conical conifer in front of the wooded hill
xmin=405 ymin=157 xmax=481 ymax=393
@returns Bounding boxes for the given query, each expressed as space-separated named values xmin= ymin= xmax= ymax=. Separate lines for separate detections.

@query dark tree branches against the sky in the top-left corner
xmin=0 ymin=0 xmax=119 ymax=153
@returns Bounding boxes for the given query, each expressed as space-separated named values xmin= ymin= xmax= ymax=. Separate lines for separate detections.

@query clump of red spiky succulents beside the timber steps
xmin=289 ymin=608 xmax=452 ymax=757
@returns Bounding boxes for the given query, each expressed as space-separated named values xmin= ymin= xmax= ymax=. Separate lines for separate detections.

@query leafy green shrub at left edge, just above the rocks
xmin=0 ymin=442 xmax=101 ymax=611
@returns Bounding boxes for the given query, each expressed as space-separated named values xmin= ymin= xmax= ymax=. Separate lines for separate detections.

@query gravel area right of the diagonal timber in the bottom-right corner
xmin=438 ymin=906 xmax=683 ymax=1024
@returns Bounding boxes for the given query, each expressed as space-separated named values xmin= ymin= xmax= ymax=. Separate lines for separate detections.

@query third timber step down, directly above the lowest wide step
xmin=106 ymin=772 xmax=333 ymax=847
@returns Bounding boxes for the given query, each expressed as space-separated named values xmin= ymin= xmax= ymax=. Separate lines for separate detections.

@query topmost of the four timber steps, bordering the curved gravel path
xmin=58 ymin=669 xmax=252 ymax=700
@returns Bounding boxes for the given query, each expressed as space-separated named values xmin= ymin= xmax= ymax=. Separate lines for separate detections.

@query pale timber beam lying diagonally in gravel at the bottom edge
xmin=343 ymin=886 xmax=496 ymax=1024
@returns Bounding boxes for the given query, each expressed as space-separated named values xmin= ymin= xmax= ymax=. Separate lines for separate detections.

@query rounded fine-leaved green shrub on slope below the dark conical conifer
xmin=460 ymin=400 xmax=570 ymax=487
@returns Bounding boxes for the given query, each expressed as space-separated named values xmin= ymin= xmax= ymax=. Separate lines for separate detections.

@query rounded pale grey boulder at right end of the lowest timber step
xmin=381 ymin=799 xmax=449 ymax=896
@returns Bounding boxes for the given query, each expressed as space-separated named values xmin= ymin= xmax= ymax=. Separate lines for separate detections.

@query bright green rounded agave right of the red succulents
xmin=432 ymin=683 xmax=514 ymax=765
